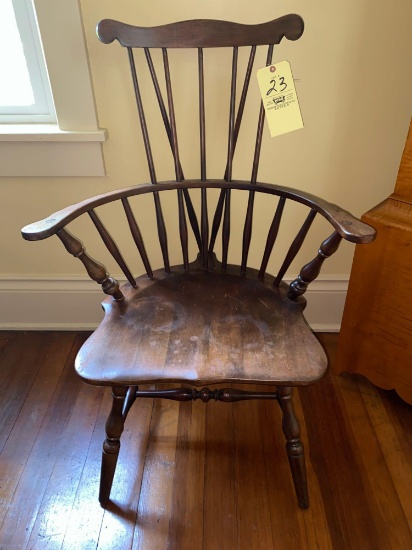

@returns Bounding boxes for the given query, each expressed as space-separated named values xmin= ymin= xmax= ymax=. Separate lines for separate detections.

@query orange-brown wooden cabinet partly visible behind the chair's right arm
xmin=334 ymin=121 xmax=412 ymax=403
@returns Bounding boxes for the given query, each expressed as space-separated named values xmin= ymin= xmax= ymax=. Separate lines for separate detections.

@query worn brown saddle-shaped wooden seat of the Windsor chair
xmin=76 ymin=266 xmax=327 ymax=386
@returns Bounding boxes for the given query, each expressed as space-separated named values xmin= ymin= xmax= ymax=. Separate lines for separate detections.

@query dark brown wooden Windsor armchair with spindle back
xmin=22 ymin=15 xmax=375 ymax=508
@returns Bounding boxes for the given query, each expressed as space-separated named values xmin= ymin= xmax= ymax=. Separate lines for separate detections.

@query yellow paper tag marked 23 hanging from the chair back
xmin=257 ymin=61 xmax=303 ymax=137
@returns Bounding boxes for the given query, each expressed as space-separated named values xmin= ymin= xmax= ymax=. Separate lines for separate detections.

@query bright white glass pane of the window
xmin=0 ymin=0 xmax=35 ymax=106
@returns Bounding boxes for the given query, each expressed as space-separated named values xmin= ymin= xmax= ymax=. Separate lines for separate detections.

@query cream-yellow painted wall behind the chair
xmin=0 ymin=0 xmax=412 ymax=277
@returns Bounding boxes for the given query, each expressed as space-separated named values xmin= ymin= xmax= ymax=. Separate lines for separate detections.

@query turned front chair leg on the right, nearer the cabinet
xmin=278 ymin=386 xmax=309 ymax=509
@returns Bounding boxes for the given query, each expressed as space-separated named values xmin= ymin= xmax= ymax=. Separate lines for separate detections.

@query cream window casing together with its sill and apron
xmin=0 ymin=0 xmax=107 ymax=177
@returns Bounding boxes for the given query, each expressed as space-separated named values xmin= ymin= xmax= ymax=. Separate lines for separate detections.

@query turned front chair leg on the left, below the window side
xmin=99 ymin=386 xmax=127 ymax=508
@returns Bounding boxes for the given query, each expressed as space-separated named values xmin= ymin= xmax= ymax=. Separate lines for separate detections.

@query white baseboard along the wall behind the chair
xmin=0 ymin=275 xmax=348 ymax=332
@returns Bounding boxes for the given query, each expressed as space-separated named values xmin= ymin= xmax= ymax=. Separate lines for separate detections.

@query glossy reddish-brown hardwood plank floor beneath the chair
xmin=0 ymin=332 xmax=412 ymax=550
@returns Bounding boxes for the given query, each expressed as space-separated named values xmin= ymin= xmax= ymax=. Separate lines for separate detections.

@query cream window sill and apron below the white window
xmin=0 ymin=124 xmax=107 ymax=177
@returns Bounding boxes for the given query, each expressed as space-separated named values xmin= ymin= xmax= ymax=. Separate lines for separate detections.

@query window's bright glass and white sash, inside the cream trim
xmin=0 ymin=0 xmax=56 ymax=123
